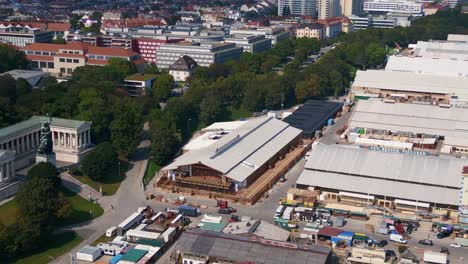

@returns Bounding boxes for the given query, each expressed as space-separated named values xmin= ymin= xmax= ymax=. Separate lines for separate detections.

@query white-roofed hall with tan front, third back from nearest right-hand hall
xmin=349 ymin=70 xmax=468 ymax=105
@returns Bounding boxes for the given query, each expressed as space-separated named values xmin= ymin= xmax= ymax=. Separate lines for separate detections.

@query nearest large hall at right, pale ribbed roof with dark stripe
xmin=296 ymin=143 xmax=468 ymax=217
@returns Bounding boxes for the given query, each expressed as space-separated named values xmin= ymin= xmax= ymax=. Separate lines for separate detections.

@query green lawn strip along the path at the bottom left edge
xmin=12 ymin=231 xmax=82 ymax=264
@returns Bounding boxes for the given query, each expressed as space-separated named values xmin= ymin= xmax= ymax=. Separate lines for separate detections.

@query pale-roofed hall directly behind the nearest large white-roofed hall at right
xmin=348 ymin=100 xmax=468 ymax=154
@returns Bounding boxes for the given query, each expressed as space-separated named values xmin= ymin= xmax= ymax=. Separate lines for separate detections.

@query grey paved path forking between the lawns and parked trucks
xmin=52 ymin=140 xmax=149 ymax=264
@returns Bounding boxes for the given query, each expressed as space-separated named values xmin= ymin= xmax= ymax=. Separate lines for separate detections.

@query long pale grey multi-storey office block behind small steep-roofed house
xmin=156 ymin=42 xmax=242 ymax=69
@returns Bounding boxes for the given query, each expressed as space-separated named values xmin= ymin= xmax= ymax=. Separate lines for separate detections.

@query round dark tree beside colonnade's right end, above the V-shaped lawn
xmin=81 ymin=142 xmax=117 ymax=181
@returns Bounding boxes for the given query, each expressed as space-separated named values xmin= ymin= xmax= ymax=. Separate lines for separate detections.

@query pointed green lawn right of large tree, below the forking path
xmin=61 ymin=188 xmax=104 ymax=226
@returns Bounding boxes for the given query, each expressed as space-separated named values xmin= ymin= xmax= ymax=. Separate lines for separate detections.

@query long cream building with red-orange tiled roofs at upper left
xmin=23 ymin=42 xmax=146 ymax=76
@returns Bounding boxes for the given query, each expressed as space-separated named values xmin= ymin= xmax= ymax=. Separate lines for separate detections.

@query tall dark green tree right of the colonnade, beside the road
xmin=110 ymin=98 xmax=143 ymax=157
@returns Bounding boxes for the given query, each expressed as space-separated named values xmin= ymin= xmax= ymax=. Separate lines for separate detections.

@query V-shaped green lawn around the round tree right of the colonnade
xmin=72 ymin=161 xmax=130 ymax=195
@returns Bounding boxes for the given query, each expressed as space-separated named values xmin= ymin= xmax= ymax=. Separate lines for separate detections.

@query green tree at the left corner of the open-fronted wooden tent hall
xmin=151 ymin=123 xmax=179 ymax=164
